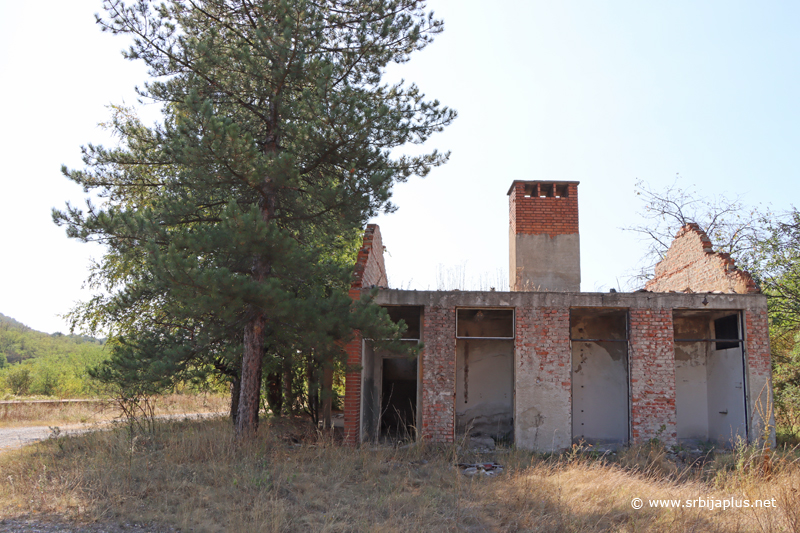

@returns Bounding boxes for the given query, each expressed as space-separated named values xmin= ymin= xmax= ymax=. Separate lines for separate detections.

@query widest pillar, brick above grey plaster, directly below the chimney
xmin=514 ymin=307 xmax=572 ymax=452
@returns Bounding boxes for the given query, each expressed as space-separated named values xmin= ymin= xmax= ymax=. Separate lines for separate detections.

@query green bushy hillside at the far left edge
xmin=0 ymin=313 xmax=106 ymax=397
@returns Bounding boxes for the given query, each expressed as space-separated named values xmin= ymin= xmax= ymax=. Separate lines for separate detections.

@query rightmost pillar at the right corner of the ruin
xmin=744 ymin=308 xmax=775 ymax=446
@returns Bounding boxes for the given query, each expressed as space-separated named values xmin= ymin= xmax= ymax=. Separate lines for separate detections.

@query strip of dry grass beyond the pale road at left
xmin=0 ymin=394 xmax=230 ymax=428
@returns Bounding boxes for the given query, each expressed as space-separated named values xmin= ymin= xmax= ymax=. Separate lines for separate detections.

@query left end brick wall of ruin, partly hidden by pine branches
xmin=344 ymin=224 xmax=388 ymax=445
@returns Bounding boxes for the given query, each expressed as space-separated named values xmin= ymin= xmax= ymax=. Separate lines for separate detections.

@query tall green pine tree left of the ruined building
xmin=54 ymin=0 xmax=455 ymax=435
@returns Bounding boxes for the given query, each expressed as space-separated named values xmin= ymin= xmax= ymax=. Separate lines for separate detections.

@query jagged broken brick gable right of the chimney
xmin=645 ymin=224 xmax=759 ymax=294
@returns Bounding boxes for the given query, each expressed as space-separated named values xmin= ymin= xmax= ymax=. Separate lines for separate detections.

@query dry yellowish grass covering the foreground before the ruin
xmin=0 ymin=419 xmax=800 ymax=533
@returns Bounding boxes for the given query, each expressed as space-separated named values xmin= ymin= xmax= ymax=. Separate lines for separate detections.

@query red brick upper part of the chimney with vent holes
xmin=508 ymin=181 xmax=578 ymax=237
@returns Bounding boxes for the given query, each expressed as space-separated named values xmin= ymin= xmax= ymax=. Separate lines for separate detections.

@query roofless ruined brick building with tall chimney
xmin=345 ymin=181 xmax=774 ymax=451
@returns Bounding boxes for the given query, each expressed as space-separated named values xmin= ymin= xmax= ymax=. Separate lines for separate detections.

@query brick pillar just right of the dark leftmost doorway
xmin=420 ymin=306 xmax=456 ymax=443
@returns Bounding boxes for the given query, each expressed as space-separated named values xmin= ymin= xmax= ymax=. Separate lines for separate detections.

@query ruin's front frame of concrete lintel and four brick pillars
xmin=348 ymin=290 xmax=774 ymax=451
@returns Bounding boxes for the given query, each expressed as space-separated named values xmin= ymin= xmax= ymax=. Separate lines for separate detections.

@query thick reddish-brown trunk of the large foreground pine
xmin=236 ymin=312 xmax=266 ymax=438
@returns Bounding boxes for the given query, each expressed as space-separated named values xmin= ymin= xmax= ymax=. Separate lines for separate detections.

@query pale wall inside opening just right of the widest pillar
xmin=570 ymin=309 xmax=629 ymax=444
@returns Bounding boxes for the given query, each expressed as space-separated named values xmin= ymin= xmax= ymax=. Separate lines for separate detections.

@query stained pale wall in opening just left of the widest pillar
xmin=455 ymin=339 xmax=514 ymax=442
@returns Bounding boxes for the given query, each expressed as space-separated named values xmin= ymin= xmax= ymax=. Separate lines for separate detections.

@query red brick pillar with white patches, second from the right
xmin=629 ymin=309 xmax=677 ymax=445
